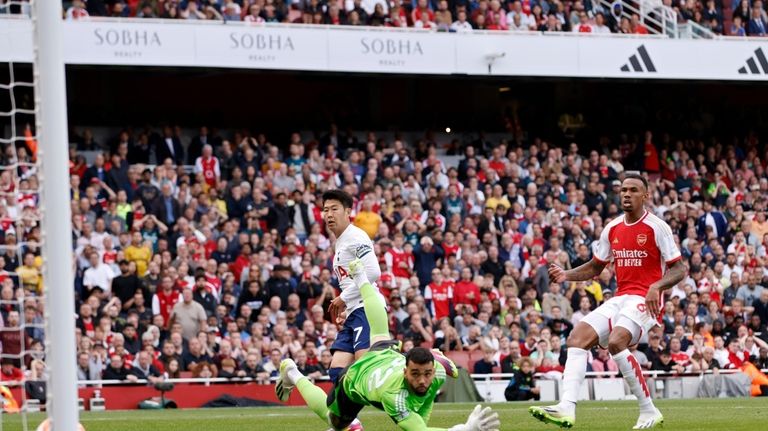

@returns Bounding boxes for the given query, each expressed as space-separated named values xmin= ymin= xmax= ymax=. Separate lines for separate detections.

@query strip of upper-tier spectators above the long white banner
xmin=40 ymin=0 xmax=756 ymax=36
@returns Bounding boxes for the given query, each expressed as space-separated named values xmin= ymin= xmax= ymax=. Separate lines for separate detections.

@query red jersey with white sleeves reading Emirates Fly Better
xmin=594 ymin=211 xmax=681 ymax=296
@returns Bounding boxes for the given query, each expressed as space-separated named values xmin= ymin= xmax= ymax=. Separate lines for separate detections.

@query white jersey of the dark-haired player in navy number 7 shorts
xmin=333 ymin=224 xmax=381 ymax=316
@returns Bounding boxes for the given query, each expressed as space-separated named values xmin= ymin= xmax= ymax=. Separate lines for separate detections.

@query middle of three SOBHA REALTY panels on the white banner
xmin=195 ymin=25 xmax=328 ymax=70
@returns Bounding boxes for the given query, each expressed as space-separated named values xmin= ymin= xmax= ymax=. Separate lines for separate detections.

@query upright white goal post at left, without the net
xmin=32 ymin=0 xmax=79 ymax=431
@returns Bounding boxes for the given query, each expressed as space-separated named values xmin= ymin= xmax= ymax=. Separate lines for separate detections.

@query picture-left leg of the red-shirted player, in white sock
xmin=528 ymin=301 xmax=617 ymax=428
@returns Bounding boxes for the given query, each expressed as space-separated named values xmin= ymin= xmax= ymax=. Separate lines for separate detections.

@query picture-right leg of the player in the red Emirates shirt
xmin=608 ymin=308 xmax=664 ymax=429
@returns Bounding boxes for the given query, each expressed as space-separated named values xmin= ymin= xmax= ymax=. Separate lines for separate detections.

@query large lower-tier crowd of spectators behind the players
xmin=0 ymin=120 xmax=768 ymax=399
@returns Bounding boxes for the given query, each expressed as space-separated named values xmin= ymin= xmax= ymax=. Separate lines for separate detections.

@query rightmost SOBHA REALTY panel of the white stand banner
xmin=328 ymin=28 xmax=456 ymax=75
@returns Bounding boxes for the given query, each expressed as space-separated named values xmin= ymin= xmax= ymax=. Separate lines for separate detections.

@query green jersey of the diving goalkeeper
xmin=342 ymin=349 xmax=446 ymax=429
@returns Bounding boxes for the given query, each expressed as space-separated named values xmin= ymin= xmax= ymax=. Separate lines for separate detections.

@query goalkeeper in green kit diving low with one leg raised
xmin=275 ymin=260 xmax=500 ymax=431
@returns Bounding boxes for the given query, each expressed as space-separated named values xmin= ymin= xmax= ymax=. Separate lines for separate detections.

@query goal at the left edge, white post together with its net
xmin=0 ymin=0 xmax=78 ymax=431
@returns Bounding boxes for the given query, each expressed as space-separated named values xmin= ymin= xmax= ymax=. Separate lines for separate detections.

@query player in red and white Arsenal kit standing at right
xmin=529 ymin=174 xmax=685 ymax=429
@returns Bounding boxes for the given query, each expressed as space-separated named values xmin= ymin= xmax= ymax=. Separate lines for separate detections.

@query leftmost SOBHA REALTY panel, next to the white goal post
xmin=63 ymin=21 xmax=197 ymax=66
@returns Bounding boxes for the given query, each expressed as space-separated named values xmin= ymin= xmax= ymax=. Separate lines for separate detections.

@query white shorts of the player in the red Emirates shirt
xmin=581 ymin=295 xmax=659 ymax=348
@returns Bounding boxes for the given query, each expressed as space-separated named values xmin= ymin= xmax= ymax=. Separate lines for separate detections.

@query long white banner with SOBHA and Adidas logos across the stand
xmin=0 ymin=18 xmax=768 ymax=81
